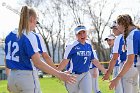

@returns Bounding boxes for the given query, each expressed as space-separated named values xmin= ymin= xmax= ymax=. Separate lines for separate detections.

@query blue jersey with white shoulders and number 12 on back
xmin=5 ymin=30 xmax=40 ymax=70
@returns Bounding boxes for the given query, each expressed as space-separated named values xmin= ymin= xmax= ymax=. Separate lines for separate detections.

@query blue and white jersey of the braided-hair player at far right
xmin=126 ymin=29 xmax=140 ymax=64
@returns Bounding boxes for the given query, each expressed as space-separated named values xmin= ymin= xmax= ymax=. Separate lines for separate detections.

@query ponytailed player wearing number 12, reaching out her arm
xmin=5 ymin=6 xmax=75 ymax=93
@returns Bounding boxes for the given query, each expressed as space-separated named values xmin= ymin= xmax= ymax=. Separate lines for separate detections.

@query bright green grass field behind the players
xmin=0 ymin=76 xmax=113 ymax=93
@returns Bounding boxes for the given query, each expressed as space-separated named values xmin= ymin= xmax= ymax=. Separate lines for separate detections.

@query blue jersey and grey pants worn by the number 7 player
xmin=64 ymin=41 xmax=94 ymax=93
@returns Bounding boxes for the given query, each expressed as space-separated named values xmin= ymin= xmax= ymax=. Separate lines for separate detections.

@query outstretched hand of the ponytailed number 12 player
xmin=58 ymin=72 xmax=76 ymax=84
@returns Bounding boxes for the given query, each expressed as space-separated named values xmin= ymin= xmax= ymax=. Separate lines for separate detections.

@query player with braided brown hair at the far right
xmin=109 ymin=14 xmax=140 ymax=93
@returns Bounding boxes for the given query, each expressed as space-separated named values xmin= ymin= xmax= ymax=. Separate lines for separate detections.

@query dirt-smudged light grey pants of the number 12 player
xmin=8 ymin=70 xmax=41 ymax=93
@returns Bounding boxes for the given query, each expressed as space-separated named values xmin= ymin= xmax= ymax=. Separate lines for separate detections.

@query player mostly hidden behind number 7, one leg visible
xmin=89 ymin=50 xmax=101 ymax=93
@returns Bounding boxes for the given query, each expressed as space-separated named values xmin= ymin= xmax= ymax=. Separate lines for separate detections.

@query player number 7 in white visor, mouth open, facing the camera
xmin=58 ymin=26 xmax=105 ymax=93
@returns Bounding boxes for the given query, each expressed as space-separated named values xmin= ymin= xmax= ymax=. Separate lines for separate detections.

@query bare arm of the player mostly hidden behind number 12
xmin=42 ymin=52 xmax=57 ymax=69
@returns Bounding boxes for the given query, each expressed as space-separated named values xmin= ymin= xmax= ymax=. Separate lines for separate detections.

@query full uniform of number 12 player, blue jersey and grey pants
xmin=5 ymin=29 xmax=41 ymax=93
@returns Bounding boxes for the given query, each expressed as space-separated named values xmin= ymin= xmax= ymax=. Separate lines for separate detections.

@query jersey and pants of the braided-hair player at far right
xmin=122 ymin=29 xmax=140 ymax=93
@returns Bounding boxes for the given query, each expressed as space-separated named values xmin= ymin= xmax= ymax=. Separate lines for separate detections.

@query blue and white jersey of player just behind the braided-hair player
xmin=112 ymin=34 xmax=126 ymax=63
